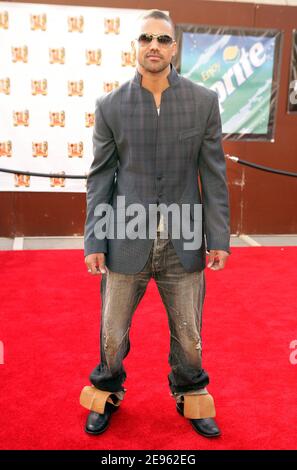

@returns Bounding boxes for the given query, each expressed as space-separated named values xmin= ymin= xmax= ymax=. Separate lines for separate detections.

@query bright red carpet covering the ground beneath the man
xmin=0 ymin=247 xmax=297 ymax=450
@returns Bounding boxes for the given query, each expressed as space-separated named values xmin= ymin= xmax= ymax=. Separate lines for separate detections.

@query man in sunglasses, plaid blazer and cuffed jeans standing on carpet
xmin=80 ymin=10 xmax=230 ymax=437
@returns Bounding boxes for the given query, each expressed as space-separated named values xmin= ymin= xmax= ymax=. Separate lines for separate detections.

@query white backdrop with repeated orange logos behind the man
xmin=0 ymin=2 xmax=145 ymax=192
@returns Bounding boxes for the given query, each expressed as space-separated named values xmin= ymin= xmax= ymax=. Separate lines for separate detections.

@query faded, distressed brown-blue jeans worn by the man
xmin=90 ymin=233 xmax=209 ymax=399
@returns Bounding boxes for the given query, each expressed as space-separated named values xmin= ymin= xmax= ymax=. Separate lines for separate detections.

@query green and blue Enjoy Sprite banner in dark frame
xmin=177 ymin=25 xmax=281 ymax=140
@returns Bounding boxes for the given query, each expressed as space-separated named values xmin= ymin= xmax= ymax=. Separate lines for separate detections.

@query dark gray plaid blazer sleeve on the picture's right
xmin=198 ymin=92 xmax=230 ymax=253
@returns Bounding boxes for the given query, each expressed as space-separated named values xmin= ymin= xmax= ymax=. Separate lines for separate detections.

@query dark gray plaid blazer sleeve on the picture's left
xmin=84 ymin=96 xmax=118 ymax=256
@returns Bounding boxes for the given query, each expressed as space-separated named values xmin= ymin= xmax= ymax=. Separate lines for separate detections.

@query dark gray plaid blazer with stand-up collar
xmin=84 ymin=64 xmax=230 ymax=274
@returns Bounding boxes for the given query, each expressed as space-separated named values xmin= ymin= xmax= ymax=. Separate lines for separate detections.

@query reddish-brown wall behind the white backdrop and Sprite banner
xmin=0 ymin=0 xmax=297 ymax=237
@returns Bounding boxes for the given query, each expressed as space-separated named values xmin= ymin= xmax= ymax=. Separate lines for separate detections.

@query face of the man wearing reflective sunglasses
xmin=132 ymin=18 xmax=176 ymax=73
